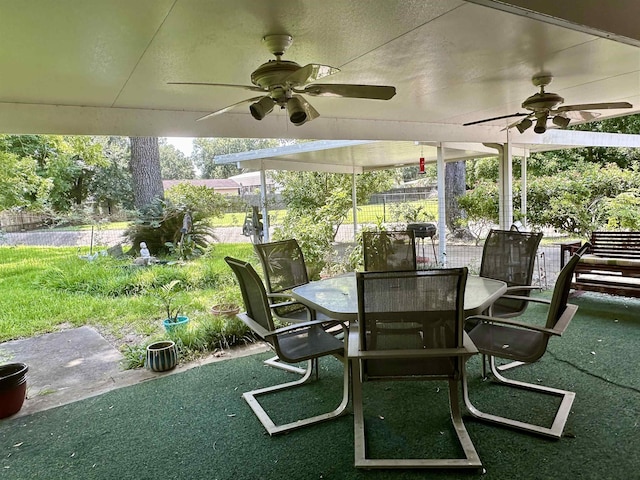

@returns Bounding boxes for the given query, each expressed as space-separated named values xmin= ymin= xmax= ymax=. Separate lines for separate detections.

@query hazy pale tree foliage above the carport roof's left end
xmin=191 ymin=138 xmax=280 ymax=178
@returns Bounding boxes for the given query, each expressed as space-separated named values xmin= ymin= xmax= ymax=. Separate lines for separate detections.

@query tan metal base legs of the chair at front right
xmin=462 ymin=356 xmax=576 ymax=438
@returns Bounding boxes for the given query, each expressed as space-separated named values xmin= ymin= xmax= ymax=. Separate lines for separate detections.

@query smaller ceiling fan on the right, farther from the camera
xmin=464 ymin=73 xmax=632 ymax=133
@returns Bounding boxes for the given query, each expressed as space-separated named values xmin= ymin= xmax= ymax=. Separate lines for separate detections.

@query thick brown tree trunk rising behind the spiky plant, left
xmin=130 ymin=137 xmax=164 ymax=209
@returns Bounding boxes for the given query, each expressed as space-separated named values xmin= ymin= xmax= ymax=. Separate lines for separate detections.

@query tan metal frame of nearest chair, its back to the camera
xmin=348 ymin=268 xmax=482 ymax=469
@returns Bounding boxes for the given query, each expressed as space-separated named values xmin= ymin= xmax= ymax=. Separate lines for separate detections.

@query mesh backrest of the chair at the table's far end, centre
xmin=362 ymin=230 xmax=416 ymax=272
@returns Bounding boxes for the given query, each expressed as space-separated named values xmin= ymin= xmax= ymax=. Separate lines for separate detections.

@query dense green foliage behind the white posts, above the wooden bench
xmin=461 ymin=115 xmax=640 ymax=236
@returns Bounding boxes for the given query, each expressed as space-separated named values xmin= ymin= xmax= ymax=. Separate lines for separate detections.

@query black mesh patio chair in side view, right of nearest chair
xmin=463 ymin=244 xmax=584 ymax=438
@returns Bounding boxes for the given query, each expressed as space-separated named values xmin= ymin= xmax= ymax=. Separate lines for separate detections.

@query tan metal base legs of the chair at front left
xmin=242 ymin=359 xmax=349 ymax=435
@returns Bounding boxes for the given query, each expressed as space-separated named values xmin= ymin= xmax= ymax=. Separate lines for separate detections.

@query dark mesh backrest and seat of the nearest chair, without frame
xmin=356 ymin=267 xmax=468 ymax=379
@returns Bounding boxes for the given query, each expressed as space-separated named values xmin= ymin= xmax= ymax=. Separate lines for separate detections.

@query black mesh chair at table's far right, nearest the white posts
xmin=480 ymin=228 xmax=542 ymax=318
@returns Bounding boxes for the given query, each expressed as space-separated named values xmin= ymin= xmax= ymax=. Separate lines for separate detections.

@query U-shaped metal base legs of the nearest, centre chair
xmin=352 ymin=360 xmax=482 ymax=469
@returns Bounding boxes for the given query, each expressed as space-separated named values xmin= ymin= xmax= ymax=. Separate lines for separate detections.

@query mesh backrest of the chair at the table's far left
xmin=253 ymin=238 xmax=309 ymax=293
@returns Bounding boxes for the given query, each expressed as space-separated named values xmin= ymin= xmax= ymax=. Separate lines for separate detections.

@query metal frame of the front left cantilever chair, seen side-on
xmin=225 ymin=257 xmax=349 ymax=435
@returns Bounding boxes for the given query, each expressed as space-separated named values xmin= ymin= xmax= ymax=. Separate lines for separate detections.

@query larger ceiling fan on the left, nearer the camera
xmin=169 ymin=35 xmax=396 ymax=125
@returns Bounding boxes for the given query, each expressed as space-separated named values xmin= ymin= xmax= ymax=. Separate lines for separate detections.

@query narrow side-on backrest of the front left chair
xmin=224 ymin=257 xmax=277 ymax=347
